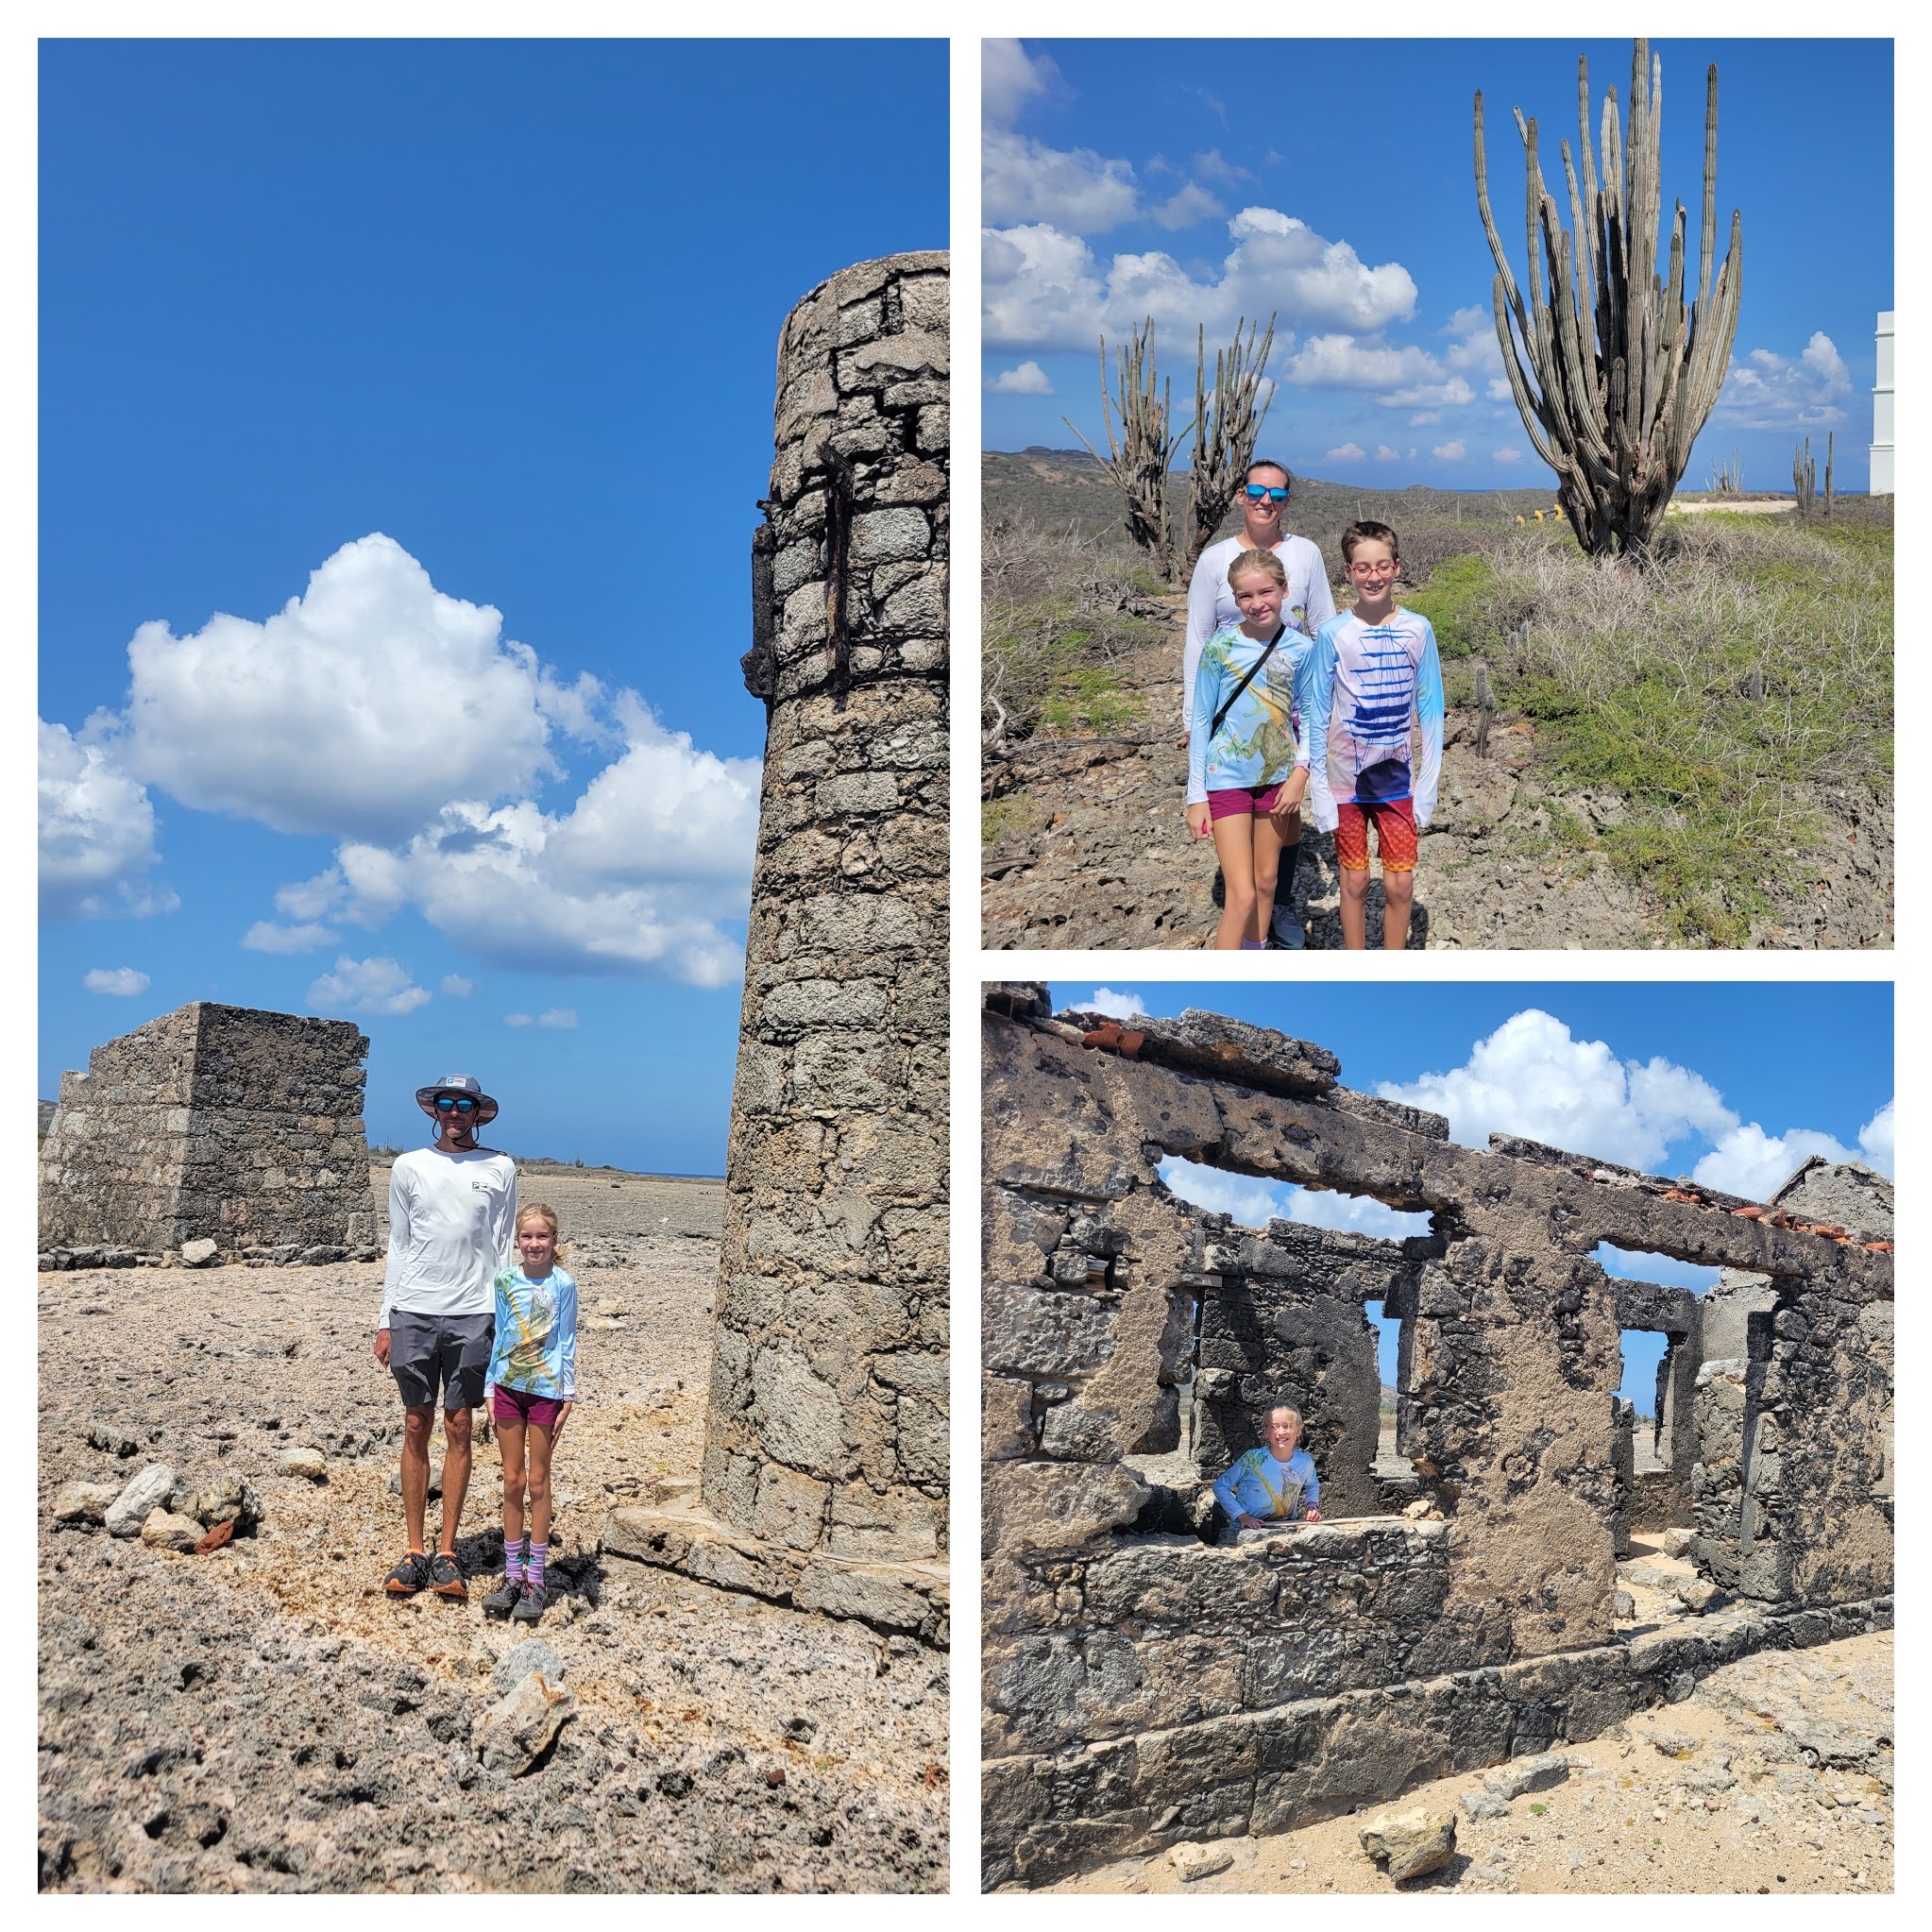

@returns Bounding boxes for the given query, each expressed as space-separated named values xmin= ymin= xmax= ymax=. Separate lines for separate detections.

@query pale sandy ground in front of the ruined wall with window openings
xmin=1043 ymin=1631 xmax=1893 ymax=1897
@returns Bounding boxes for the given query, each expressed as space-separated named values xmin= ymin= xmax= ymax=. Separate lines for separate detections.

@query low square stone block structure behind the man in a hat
xmin=41 ymin=1001 xmax=375 ymax=1260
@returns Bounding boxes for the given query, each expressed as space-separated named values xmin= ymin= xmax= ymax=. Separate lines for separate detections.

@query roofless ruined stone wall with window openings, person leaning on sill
xmin=981 ymin=985 xmax=1891 ymax=1882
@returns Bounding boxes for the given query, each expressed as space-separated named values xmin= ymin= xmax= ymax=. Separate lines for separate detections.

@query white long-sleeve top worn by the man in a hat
xmin=375 ymin=1147 xmax=516 ymax=1330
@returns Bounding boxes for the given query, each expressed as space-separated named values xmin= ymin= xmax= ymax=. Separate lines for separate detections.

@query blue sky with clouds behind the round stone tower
xmin=39 ymin=41 xmax=949 ymax=1173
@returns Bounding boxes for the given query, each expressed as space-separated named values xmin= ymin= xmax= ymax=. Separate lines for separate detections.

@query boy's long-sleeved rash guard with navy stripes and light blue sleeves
xmin=1295 ymin=604 xmax=1443 ymax=833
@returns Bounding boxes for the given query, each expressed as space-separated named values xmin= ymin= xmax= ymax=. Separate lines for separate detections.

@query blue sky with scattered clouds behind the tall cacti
xmin=981 ymin=39 xmax=1893 ymax=491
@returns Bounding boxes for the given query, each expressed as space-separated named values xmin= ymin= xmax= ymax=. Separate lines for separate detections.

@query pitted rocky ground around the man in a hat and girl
xmin=39 ymin=1169 xmax=949 ymax=1891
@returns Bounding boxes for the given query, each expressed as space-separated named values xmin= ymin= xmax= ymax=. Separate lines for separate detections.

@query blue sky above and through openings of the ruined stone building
xmin=1051 ymin=977 xmax=1891 ymax=1409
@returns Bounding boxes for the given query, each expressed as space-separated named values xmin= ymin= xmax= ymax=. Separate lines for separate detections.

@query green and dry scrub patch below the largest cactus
xmin=1402 ymin=514 xmax=1893 ymax=947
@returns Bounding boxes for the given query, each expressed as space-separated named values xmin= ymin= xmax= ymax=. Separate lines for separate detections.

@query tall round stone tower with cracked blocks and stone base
xmin=606 ymin=253 xmax=951 ymax=1638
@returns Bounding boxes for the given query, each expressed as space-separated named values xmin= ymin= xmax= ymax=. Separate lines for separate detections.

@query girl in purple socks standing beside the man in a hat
xmin=483 ymin=1202 xmax=578 ymax=1623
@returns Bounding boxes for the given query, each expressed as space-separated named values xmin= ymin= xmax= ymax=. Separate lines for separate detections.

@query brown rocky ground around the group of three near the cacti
xmin=981 ymin=599 xmax=1891 ymax=951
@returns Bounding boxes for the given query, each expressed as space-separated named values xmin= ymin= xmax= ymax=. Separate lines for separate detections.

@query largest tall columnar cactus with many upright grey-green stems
xmin=1476 ymin=41 xmax=1745 ymax=556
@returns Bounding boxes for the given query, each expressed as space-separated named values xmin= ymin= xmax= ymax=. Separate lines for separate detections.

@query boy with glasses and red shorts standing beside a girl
xmin=1296 ymin=521 xmax=1443 ymax=953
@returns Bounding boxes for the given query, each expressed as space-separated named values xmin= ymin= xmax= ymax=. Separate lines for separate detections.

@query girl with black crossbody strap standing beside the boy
xmin=1186 ymin=551 xmax=1308 ymax=953
